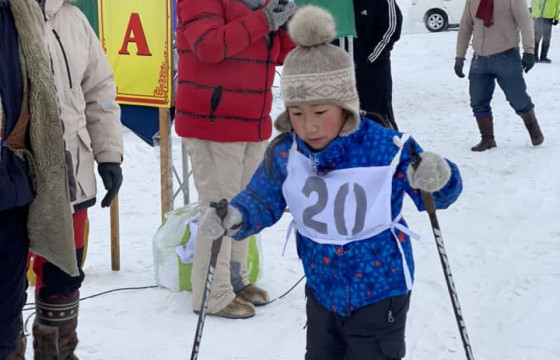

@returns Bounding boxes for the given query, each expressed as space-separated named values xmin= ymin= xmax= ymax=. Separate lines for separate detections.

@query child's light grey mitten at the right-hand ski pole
xmin=406 ymin=151 xmax=451 ymax=193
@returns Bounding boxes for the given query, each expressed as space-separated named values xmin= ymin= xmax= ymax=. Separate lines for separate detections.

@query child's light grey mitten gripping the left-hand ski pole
xmin=198 ymin=205 xmax=243 ymax=239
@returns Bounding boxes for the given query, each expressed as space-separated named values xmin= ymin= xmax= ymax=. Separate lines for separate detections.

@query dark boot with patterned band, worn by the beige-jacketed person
xmin=33 ymin=295 xmax=79 ymax=360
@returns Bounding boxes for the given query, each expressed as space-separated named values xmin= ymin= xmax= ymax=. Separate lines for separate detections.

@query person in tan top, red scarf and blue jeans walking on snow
xmin=455 ymin=0 xmax=544 ymax=151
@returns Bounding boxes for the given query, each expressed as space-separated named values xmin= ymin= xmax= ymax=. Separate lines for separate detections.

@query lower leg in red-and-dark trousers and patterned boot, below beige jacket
xmin=33 ymin=209 xmax=87 ymax=359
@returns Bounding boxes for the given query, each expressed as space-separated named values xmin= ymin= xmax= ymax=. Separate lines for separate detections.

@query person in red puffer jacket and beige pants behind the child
xmin=175 ymin=0 xmax=296 ymax=318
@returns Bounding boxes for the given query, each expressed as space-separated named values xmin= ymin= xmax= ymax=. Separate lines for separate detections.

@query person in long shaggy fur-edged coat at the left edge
xmin=0 ymin=0 xmax=79 ymax=360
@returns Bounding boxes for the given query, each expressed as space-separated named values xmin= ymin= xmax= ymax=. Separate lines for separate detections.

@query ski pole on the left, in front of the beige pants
xmin=191 ymin=199 xmax=228 ymax=360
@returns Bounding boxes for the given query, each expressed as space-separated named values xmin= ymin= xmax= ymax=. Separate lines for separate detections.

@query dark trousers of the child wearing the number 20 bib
xmin=305 ymin=288 xmax=410 ymax=360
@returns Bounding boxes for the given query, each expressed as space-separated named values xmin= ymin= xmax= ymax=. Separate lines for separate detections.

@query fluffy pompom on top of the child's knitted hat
xmin=288 ymin=5 xmax=336 ymax=46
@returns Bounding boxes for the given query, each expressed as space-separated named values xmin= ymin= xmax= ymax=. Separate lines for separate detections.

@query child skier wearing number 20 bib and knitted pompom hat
xmin=199 ymin=5 xmax=462 ymax=360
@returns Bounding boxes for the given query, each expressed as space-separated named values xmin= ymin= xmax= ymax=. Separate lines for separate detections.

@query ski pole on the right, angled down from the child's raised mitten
xmin=410 ymin=141 xmax=474 ymax=360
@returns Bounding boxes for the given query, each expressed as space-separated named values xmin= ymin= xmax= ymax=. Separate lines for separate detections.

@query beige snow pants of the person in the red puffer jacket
xmin=186 ymin=138 xmax=267 ymax=313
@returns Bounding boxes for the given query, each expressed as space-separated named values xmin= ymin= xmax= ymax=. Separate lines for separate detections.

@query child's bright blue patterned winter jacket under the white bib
xmin=231 ymin=119 xmax=462 ymax=316
